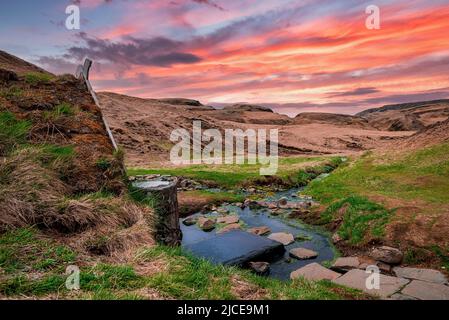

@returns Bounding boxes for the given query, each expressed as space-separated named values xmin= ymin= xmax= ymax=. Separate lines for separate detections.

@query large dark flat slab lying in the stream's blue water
xmin=185 ymin=230 xmax=285 ymax=266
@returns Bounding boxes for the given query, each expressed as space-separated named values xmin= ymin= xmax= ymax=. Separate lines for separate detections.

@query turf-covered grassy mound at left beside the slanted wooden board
xmin=0 ymin=52 xmax=154 ymax=298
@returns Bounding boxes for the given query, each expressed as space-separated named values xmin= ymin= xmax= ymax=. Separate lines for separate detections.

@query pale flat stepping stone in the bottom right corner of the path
xmin=401 ymin=280 xmax=449 ymax=300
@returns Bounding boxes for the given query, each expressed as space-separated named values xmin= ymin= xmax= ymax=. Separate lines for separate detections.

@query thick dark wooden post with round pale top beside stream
xmin=134 ymin=179 xmax=182 ymax=246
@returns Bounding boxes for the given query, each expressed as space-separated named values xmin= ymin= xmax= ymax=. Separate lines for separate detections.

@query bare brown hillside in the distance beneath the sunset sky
xmin=98 ymin=92 xmax=414 ymax=167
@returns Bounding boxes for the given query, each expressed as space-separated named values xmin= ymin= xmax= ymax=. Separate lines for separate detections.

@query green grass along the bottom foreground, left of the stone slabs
xmin=0 ymin=228 xmax=365 ymax=300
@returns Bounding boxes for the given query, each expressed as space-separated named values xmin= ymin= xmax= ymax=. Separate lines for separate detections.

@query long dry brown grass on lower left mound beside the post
xmin=0 ymin=148 xmax=154 ymax=261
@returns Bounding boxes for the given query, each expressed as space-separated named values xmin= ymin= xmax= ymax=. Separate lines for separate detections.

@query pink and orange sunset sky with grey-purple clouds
xmin=0 ymin=0 xmax=449 ymax=116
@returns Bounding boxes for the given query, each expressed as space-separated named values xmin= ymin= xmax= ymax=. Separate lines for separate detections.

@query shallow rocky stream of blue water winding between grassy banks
xmin=180 ymin=188 xmax=335 ymax=280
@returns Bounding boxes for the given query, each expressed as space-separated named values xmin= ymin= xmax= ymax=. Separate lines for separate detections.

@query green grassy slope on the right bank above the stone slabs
xmin=304 ymin=143 xmax=449 ymax=245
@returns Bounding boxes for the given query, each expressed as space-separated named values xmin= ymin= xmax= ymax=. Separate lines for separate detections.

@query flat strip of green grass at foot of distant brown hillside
xmin=128 ymin=157 xmax=341 ymax=189
